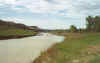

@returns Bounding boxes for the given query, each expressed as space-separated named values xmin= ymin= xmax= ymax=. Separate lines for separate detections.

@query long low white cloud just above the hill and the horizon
xmin=3 ymin=17 xmax=71 ymax=29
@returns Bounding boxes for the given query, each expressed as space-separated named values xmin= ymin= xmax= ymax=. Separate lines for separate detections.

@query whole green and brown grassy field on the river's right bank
xmin=33 ymin=33 xmax=100 ymax=63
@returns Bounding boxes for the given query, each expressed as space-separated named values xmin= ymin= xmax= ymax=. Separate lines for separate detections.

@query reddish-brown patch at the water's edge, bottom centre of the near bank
xmin=33 ymin=45 xmax=57 ymax=63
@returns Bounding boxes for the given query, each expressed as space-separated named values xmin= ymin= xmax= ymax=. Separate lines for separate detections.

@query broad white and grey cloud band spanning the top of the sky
xmin=0 ymin=0 xmax=100 ymax=15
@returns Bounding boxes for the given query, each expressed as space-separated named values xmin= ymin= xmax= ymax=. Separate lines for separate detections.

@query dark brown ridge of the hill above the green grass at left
xmin=0 ymin=20 xmax=38 ymax=30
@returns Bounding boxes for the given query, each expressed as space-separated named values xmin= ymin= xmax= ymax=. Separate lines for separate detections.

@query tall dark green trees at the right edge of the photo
xmin=86 ymin=16 xmax=100 ymax=32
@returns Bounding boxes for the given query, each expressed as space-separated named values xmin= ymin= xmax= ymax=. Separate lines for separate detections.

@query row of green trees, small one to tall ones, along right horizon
xmin=70 ymin=16 xmax=100 ymax=32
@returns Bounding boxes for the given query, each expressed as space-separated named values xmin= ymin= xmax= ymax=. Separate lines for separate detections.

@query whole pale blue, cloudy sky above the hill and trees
xmin=0 ymin=0 xmax=100 ymax=29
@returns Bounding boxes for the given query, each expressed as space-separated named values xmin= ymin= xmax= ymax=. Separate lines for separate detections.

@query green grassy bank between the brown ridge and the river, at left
xmin=0 ymin=29 xmax=37 ymax=40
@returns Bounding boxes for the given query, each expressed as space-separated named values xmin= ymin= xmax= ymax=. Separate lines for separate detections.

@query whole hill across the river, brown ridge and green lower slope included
xmin=0 ymin=20 xmax=38 ymax=40
